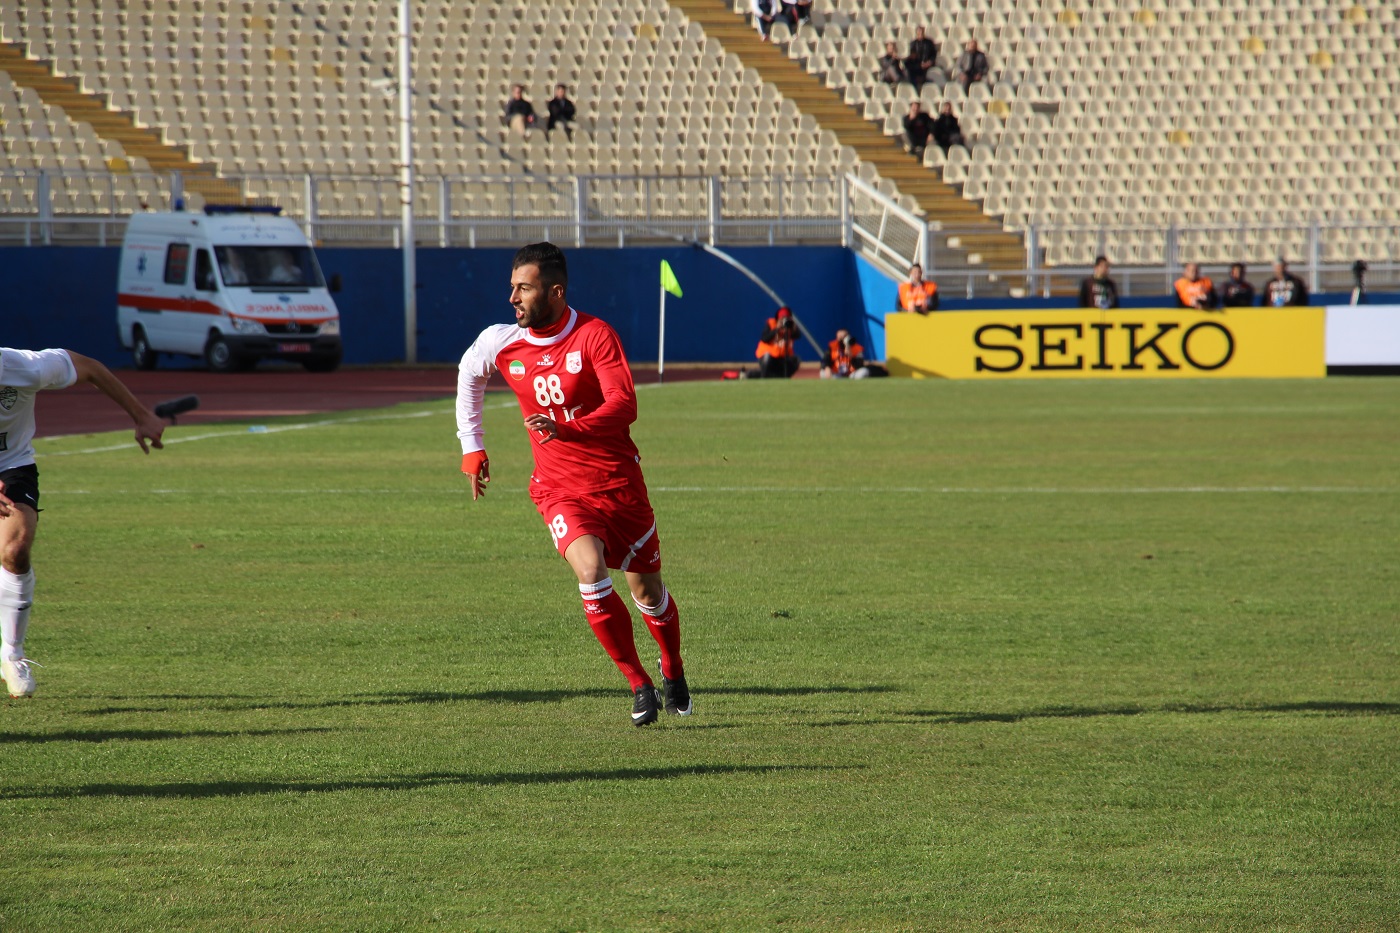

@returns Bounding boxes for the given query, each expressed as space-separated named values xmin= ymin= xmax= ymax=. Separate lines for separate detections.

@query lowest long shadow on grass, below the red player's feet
xmin=0 ymin=765 xmax=855 ymax=800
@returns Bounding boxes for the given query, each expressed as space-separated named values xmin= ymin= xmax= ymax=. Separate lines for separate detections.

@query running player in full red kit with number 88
xmin=456 ymin=242 xmax=692 ymax=726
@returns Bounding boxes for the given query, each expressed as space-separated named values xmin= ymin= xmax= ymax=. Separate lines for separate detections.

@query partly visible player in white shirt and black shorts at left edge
xmin=0 ymin=347 xmax=165 ymax=698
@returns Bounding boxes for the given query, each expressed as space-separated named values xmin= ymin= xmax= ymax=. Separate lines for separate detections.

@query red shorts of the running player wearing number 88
xmin=535 ymin=486 xmax=661 ymax=573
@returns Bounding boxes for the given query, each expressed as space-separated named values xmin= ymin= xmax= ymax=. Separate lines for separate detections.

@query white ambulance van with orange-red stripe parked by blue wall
xmin=116 ymin=205 xmax=342 ymax=373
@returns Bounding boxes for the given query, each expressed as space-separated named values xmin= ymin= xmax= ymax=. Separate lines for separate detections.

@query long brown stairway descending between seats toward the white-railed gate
xmin=669 ymin=0 xmax=1026 ymax=270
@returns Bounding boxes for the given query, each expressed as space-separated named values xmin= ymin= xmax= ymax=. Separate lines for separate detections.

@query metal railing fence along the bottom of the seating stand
xmin=0 ymin=170 xmax=1400 ymax=297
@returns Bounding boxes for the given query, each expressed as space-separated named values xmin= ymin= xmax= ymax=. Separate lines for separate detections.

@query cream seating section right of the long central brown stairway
xmin=784 ymin=0 xmax=1400 ymax=265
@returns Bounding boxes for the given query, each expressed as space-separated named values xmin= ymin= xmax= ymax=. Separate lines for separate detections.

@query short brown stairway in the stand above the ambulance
xmin=0 ymin=42 xmax=242 ymax=203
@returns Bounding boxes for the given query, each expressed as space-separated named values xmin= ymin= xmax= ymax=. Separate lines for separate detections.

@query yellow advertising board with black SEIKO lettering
xmin=885 ymin=308 xmax=1327 ymax=380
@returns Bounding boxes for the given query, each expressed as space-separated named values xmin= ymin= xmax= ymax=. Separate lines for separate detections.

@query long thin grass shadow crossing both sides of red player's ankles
xmin=83 ymin=684 xmax=897 ymax=716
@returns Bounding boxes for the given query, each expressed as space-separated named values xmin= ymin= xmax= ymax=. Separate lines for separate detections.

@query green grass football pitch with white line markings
xmin=0 ymin=378 xmax=1400 ymax=933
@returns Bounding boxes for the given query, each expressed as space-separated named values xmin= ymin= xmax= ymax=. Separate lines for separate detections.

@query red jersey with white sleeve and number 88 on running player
xmin=456 ymin=308 xmax=645 ymax=496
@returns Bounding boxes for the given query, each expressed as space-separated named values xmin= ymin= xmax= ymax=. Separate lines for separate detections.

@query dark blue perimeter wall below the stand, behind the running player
xmin=0 ymin=247 xmax=1383 ymax=367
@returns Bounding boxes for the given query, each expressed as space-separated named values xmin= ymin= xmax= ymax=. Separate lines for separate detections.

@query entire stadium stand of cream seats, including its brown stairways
xmin=0 ymin=0 xmax=1400 ymax=274
